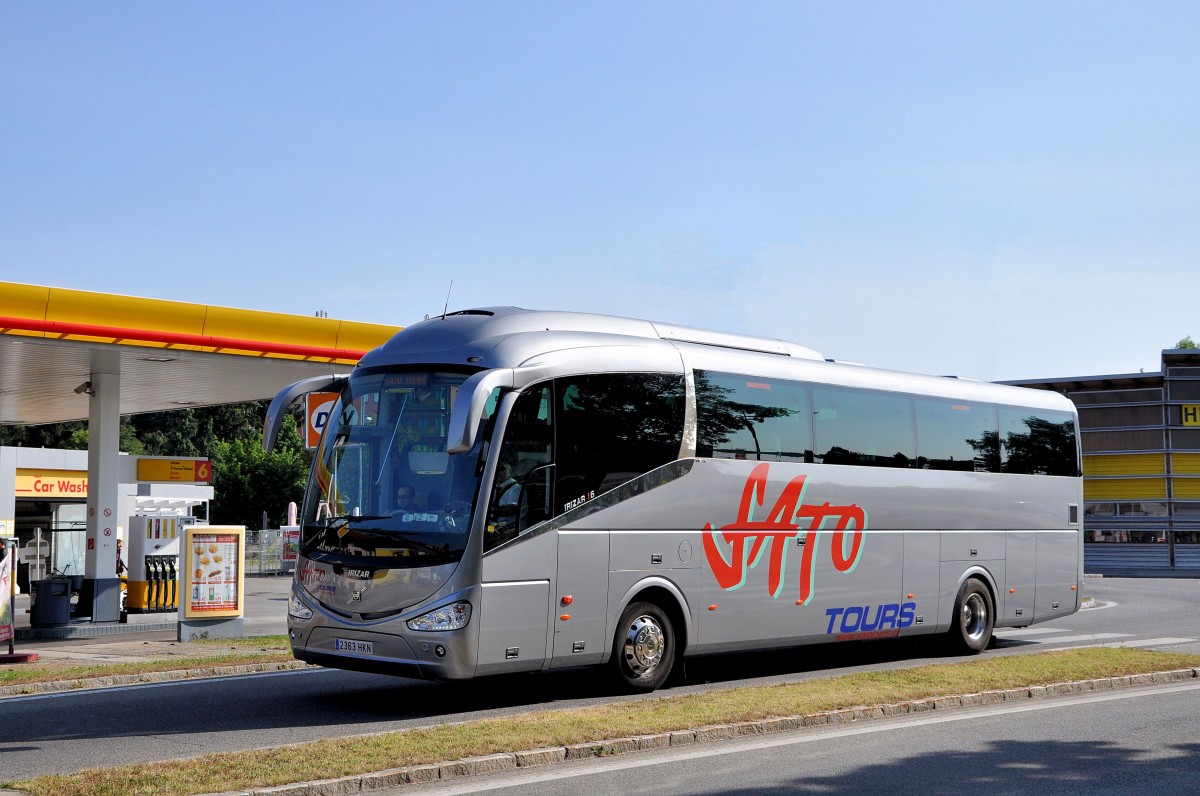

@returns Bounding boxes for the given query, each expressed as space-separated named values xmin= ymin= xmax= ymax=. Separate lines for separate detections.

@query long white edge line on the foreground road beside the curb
xmin=404 ymin=683 xmax=1200 ymax=796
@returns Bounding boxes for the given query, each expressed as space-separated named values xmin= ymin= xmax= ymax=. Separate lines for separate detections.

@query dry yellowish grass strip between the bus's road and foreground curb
xmin=4 ymin=647 xmax=1200 ymax=796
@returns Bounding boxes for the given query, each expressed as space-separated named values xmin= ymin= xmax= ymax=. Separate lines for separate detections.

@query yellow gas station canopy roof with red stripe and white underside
xmin=0 ymin=282 xmax=400 ymax=425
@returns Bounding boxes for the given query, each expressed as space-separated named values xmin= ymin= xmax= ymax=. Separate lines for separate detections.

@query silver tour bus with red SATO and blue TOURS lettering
xmin=264 ymin=307 xmax=1082 ymax=690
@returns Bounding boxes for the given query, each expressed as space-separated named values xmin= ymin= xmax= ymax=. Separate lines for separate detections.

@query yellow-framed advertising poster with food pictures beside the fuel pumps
xmin=184 ymin=526 xmax=245 ymax=618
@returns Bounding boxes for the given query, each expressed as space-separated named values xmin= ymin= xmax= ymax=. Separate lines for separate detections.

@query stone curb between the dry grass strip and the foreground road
xmin=192 ymin=668 xmax=1200 ymax=796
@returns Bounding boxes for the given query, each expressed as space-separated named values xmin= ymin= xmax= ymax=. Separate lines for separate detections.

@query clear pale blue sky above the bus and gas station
xmin=0 ymin=0 xmax=1200 ymax=379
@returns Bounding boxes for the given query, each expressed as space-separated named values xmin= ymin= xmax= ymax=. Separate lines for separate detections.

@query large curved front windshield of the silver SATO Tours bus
xmin=300 ymin=370 xmax=482 ymax=568
